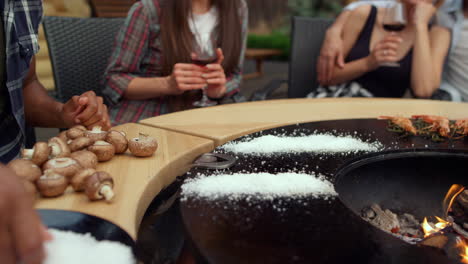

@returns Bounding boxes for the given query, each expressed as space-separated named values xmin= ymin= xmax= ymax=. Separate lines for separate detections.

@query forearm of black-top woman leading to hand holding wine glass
xmin=330 ymin=57 xmax=375 ymax=85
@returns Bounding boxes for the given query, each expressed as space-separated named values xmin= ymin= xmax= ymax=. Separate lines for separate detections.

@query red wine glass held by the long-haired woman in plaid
xmin=192 ymin=41 xmax=218 ymax=107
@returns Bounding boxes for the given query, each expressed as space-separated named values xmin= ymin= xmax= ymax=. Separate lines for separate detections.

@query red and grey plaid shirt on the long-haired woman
xmin=103 ymin=0 xmax=248 ymax=125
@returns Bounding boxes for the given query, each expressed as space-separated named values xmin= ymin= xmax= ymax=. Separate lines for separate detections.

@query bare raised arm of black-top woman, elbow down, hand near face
xmin=411 ymin=4 xmax=450 ymax=98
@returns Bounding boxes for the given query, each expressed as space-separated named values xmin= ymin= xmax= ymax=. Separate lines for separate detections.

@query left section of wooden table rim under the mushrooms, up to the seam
xmin=36 ymin=124 xmax=214 ymax=239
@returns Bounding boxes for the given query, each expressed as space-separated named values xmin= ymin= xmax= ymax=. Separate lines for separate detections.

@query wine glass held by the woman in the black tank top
xmin=382 ymin=2 xmax=407 ymax=67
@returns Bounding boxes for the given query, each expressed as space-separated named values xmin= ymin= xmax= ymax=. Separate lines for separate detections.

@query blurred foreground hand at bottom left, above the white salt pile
xmin=0 ymin=164 xmax=51 ymax=264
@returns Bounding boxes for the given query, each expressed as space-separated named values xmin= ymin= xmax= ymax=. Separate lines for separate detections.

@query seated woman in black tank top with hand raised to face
xmin=310 ymin=0 xmax=450 ymax=97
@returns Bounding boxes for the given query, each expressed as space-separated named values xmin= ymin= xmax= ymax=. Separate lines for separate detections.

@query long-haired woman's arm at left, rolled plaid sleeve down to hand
xmin=104 ymin=3 xmax=205 ymax=103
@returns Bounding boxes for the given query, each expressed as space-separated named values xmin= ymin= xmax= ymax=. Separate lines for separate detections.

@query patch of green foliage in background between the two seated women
xmin=247 ymin=32 xmax=291 ymax=60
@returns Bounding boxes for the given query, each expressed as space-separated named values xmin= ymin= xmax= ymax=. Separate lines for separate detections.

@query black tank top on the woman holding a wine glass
xmin=346 ymin=6 xmax=413 ymax=97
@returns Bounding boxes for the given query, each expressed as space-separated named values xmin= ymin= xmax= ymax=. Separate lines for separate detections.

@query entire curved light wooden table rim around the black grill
xmin=37 ymin=98 xmax=468 ymax=239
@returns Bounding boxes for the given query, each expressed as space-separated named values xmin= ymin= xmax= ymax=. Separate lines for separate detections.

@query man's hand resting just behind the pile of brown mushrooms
xmin=61 ymin=91 xmax=110 ymax=130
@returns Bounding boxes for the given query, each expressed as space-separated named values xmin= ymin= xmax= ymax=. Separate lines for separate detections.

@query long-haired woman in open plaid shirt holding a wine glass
xmin=104 ymin=0 xmax=247 ymax=125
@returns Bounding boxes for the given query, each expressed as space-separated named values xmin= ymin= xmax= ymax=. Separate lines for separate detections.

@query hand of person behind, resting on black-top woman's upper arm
xmin=317 ymin=29 xmax=344 ymax=85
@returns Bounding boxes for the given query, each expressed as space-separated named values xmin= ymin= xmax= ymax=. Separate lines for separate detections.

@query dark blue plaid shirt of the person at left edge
xmin=0 ymin=0 xmax=42 ymax=162
